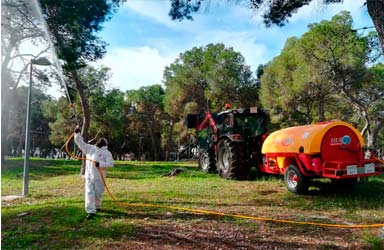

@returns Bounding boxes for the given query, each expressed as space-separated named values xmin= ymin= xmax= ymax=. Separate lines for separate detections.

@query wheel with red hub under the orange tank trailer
xmin=284 ymin=165 xmax=308 ymax=194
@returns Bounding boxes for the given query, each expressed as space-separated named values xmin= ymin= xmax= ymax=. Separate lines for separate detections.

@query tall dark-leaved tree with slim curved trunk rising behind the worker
xmin=41 ymin=0 xmax=122 ymax=148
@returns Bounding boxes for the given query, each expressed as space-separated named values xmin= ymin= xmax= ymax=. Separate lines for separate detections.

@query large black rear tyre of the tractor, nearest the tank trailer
xmin=217 ymin=139 xmax=249 ymax=180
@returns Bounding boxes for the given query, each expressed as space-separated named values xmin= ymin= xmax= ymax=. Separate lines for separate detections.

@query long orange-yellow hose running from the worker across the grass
xmin=65 ymin=133 xmax=384 ymax=229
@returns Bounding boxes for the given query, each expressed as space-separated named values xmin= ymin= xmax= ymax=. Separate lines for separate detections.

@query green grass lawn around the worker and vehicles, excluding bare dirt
xmin=1 ymin=159 xmax=384 ymax=249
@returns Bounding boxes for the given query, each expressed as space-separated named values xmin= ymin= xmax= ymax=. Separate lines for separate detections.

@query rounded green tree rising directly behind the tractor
xmin=163 ymin=43 xmax=259 ymax=146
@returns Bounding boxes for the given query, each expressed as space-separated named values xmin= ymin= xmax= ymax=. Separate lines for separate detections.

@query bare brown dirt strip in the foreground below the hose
xmin=103 ymin=220 xmax=376 ymax=250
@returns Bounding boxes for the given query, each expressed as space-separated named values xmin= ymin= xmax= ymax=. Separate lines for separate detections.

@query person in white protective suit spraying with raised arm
xmin=75 ymin=127 xmax=113 ymax=220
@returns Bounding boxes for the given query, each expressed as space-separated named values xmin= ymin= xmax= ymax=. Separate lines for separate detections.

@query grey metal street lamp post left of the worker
xmin=22 ymin=57 xmax=51 ymax=196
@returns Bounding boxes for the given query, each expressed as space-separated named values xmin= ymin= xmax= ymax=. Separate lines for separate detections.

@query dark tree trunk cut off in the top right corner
xmin=367 ymin=0 xmax=384 ymax=53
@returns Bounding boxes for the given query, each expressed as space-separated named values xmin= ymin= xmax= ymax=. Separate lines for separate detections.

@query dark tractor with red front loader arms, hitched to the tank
xmin=185 ymin=107 xmax=269 ymax=180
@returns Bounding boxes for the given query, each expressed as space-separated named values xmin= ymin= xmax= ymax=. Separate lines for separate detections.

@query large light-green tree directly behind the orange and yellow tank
xmin=261 ymin=12 xmax=384 ymax=146
